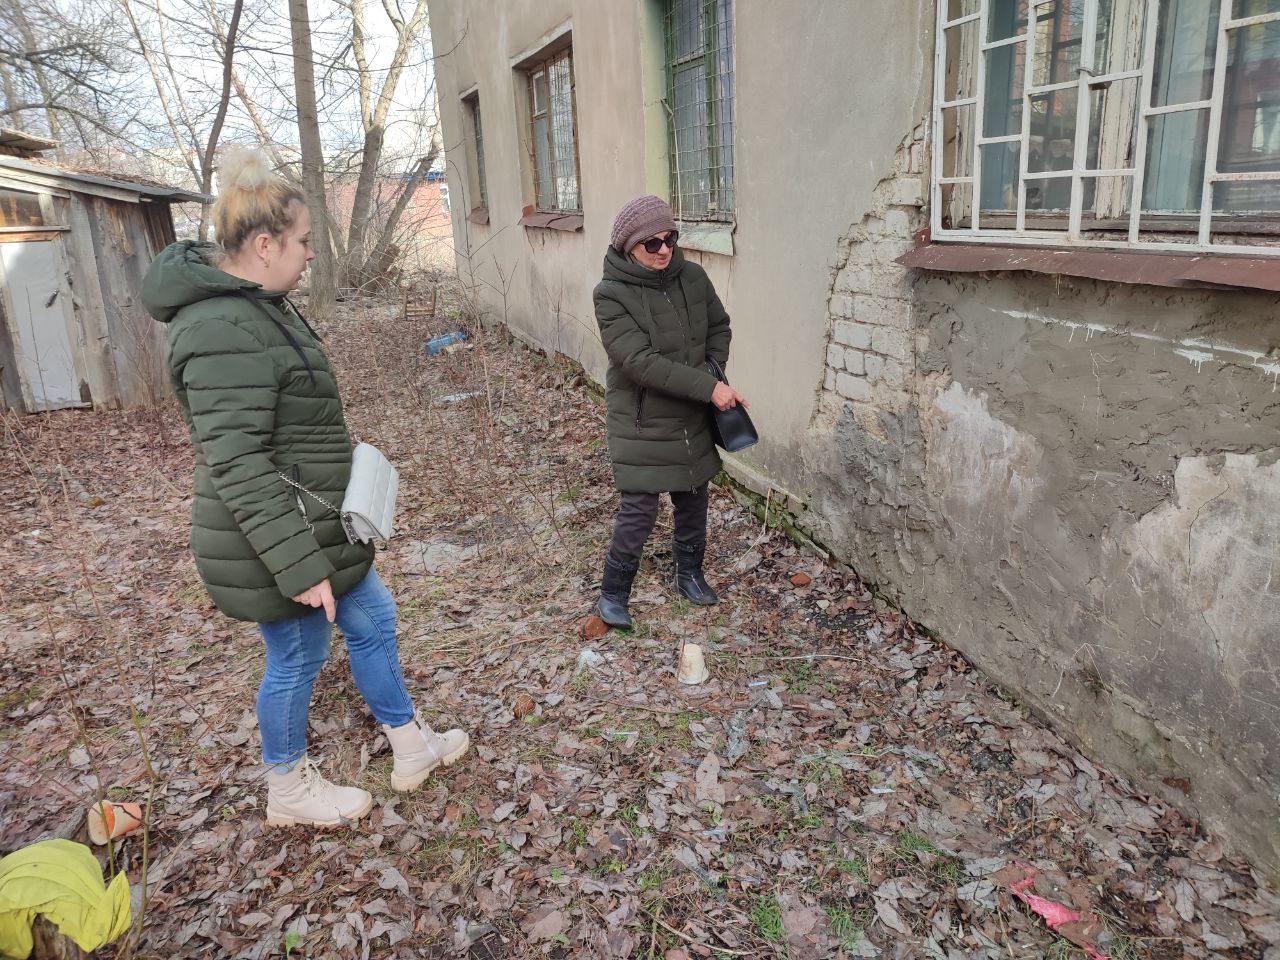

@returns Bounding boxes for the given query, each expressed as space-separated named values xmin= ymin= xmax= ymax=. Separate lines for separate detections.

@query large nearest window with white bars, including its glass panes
xmin=932 ymin=0 xmax=1280 ymax=256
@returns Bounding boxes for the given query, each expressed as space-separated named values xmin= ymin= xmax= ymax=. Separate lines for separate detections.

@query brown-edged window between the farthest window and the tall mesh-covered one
xmin=529 ymin=50 xmax=582 ymax=212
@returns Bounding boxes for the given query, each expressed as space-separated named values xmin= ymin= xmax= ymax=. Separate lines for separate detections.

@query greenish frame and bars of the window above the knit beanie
xmin=662 ymin=0 xmax=737 ymax=225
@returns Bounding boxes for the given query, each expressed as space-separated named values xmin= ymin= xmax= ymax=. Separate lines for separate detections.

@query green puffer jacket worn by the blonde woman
xmin=142 ymin=241 xmax=374 ymax=623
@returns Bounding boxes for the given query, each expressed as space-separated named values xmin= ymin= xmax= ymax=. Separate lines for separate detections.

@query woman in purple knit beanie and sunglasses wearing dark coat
xmin=595 ymin=196 xmax=746 ymax=628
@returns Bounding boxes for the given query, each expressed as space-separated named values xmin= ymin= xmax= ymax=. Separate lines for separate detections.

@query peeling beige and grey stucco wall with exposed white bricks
xmin=431 ymin=0 xmax=1280 ymax=872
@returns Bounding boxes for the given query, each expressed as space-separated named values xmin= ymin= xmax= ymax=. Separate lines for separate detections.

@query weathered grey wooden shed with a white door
xmin=0 ymin=128 xmax=206 ymax=412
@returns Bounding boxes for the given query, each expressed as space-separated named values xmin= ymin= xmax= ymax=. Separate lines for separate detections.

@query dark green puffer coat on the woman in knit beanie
xmin=595 ymin=247 xmax=730 ymax=493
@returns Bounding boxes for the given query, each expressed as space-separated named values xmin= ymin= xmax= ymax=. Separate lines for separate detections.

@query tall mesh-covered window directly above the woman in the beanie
xmin=666 ymin=0 xmax=733 ymax=221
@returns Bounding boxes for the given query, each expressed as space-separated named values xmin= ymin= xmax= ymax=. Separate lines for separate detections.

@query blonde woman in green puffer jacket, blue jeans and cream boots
xmin=143 ymin=151 xmax=468 ymax=826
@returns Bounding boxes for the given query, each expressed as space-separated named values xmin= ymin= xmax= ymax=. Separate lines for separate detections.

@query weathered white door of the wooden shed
xmin=0 ymin=238 xmax=81 ymax=410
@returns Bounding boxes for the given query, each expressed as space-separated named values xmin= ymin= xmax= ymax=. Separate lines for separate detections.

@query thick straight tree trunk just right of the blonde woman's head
xmin=289 ymin=0 xmax=338 ymax=319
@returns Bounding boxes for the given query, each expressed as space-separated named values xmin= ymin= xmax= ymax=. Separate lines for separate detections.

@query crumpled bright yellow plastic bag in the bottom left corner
xmin=0 ymin=840 xmax=132 ymax=960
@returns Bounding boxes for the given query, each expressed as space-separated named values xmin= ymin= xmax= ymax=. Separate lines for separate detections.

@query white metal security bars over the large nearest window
xmin=931 ymin=0 xmax=1280 ymax=257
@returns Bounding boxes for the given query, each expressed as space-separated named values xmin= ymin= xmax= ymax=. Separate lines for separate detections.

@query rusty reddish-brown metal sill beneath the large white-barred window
xmin=893 ymin=243 xmax=1280 ymax=292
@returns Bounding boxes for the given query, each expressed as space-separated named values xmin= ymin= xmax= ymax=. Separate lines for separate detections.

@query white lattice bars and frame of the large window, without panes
xmin=931 ymin=0 xmax=1280 ymax=257
